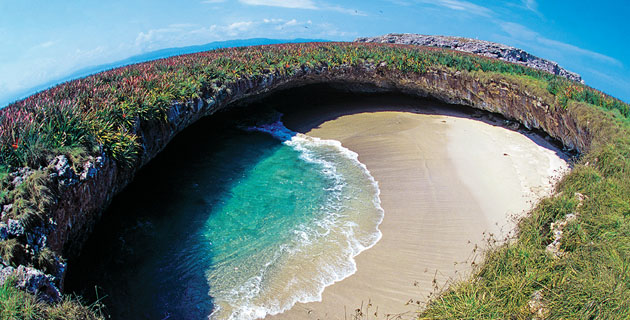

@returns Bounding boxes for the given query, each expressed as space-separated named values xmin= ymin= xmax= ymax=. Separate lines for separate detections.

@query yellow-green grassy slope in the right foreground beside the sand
xmin=421 ymin=109 xmax=630 ymax=319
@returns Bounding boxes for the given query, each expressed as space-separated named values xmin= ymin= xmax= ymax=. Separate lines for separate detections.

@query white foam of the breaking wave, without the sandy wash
xmin=210 ymin=120 xmax=384 ymax=320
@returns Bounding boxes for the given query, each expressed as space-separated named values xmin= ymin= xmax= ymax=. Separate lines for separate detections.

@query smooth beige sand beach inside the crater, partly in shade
xmin=267 ymin=99 xmax=567 ymax=319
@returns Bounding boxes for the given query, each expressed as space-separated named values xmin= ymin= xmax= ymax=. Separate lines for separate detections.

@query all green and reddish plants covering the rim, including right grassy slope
xmin=0 ymin=43 xmax=630 ymax=319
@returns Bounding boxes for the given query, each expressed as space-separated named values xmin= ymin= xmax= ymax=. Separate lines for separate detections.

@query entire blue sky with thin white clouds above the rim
xmin=0 ymin=0 xmax=630 ymax=107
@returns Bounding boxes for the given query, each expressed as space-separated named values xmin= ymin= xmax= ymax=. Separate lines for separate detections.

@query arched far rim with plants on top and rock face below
xmin=0 ymin=43 xmax=630 ymax=318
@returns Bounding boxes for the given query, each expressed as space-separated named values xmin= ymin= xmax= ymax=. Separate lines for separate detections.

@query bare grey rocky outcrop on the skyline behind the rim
xmin=354 ymin=33 xmax=584 ymax=83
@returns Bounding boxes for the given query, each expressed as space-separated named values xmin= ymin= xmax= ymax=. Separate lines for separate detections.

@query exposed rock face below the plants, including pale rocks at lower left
xmin=0 ymin=45 xmax=604 ymax=302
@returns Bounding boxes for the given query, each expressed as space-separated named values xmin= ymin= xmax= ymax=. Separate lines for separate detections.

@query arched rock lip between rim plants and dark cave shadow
xmin=48 ymin=64 xmax=591 ymax=256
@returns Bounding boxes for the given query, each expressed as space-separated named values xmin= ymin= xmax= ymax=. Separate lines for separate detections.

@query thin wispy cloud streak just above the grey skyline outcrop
xmin=499 ymin=22 xmax=623 ymax=67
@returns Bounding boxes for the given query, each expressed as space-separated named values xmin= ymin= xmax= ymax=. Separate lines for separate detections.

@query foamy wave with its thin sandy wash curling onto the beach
xmin=210 ymin=120 xmax=384 ymax=320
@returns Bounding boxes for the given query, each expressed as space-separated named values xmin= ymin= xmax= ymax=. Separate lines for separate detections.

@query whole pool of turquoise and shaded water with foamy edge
xmin=70 ymin=116 xmax=383 ymax=319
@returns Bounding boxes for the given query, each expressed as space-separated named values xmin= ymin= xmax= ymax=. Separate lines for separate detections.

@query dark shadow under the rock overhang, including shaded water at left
xmin=65 ymin=83 xmax=572 ymax=319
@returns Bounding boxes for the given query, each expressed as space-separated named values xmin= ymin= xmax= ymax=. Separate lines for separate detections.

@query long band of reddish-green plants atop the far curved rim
xmin=0 ymin=43 xmax=629 ymax=167
